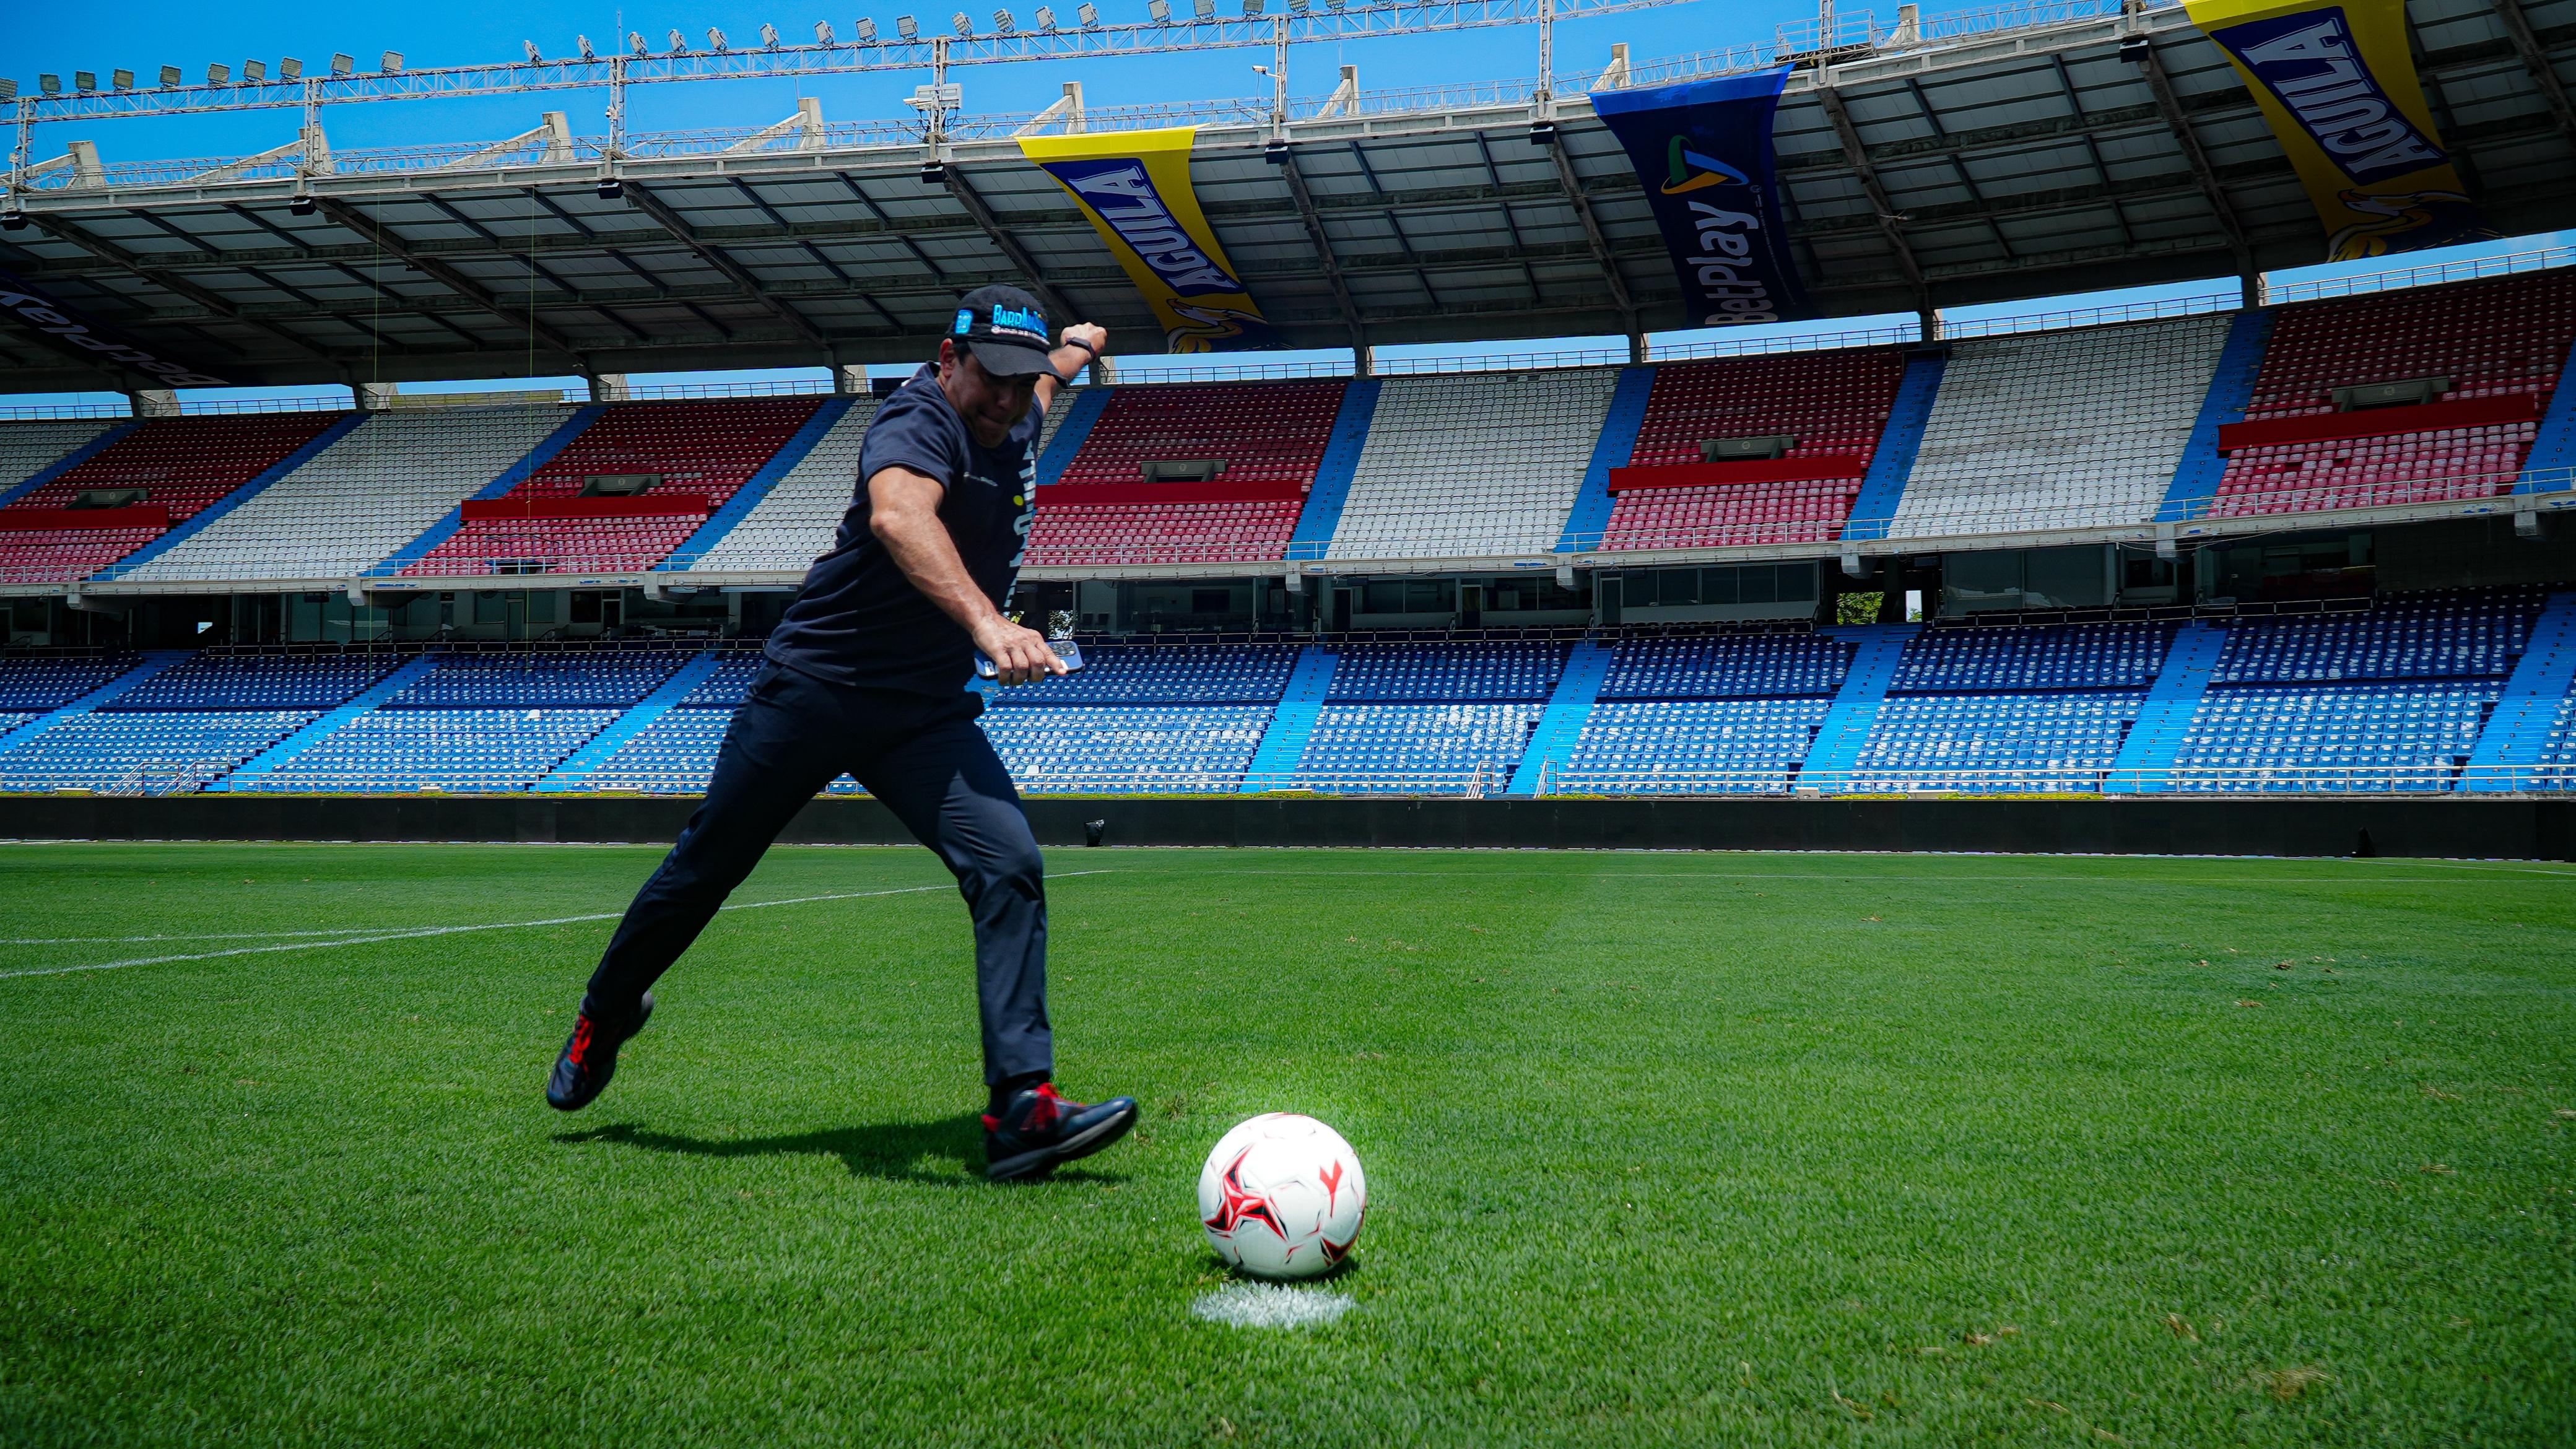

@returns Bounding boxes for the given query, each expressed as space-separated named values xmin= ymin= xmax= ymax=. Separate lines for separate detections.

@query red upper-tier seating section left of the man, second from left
xmin=399 ymin=397 xmax=819 ymax=578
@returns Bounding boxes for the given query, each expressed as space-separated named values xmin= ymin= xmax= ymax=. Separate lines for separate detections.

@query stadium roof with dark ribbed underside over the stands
xmin=0 ymin=0 xmax=2576 ymax=389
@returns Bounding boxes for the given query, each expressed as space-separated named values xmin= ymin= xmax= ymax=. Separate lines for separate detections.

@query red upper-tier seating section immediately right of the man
xmin=1028 ymin=379 xmax=1347 ymax=565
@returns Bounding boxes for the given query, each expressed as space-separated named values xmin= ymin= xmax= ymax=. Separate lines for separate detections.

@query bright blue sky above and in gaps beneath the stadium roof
xmin=0 ymin=0 xmax=2563 ymax=407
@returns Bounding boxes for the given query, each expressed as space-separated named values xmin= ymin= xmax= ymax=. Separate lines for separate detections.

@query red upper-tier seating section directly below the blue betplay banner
xmin=1599 ymin=348 xmax=1906 ymax=549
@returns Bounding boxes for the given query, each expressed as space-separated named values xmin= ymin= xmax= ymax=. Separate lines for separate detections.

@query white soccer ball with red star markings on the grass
xmin=1198 ymin=1112 xmax=1368 ymax=1279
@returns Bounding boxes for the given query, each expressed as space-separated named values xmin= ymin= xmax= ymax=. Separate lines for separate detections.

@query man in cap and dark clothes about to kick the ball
xmin=546 ymin=286 xmax=1136 ymax=1181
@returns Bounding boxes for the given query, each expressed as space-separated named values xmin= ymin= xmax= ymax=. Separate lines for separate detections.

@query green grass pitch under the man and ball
xmin=0 ymin=846 xmax=2576 ymax=1447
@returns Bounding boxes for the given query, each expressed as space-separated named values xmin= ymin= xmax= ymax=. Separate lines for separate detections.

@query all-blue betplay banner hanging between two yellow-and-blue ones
xmin=1592 ymin=67 xmax=1816 ymax=328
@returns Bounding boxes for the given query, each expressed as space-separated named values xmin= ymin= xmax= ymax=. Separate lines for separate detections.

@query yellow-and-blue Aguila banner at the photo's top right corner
xmin=2185 ymin=0 xmax=2499 ymax=261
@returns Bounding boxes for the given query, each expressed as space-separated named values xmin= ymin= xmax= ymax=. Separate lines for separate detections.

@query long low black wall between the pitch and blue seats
xmin=0 ymin=794 xmax=2576 ymax=861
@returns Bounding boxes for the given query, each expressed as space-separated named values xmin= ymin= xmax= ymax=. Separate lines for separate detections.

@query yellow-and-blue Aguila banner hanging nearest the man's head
xmin=1020 ymin=126 xmax=1283 ymax=353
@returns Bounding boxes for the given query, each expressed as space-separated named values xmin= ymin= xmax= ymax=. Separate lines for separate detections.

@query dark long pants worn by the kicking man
xmin=585 ymin=663 xmax=1053 ymax=1083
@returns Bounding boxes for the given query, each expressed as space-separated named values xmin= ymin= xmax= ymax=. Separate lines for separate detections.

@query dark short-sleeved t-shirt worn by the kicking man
xmin=768 ymin=366 xmax=1041 ymax=696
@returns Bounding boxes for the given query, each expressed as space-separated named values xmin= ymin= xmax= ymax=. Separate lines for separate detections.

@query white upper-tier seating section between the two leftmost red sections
xmin=126 ymin=407 xmax=569 ymax=580
